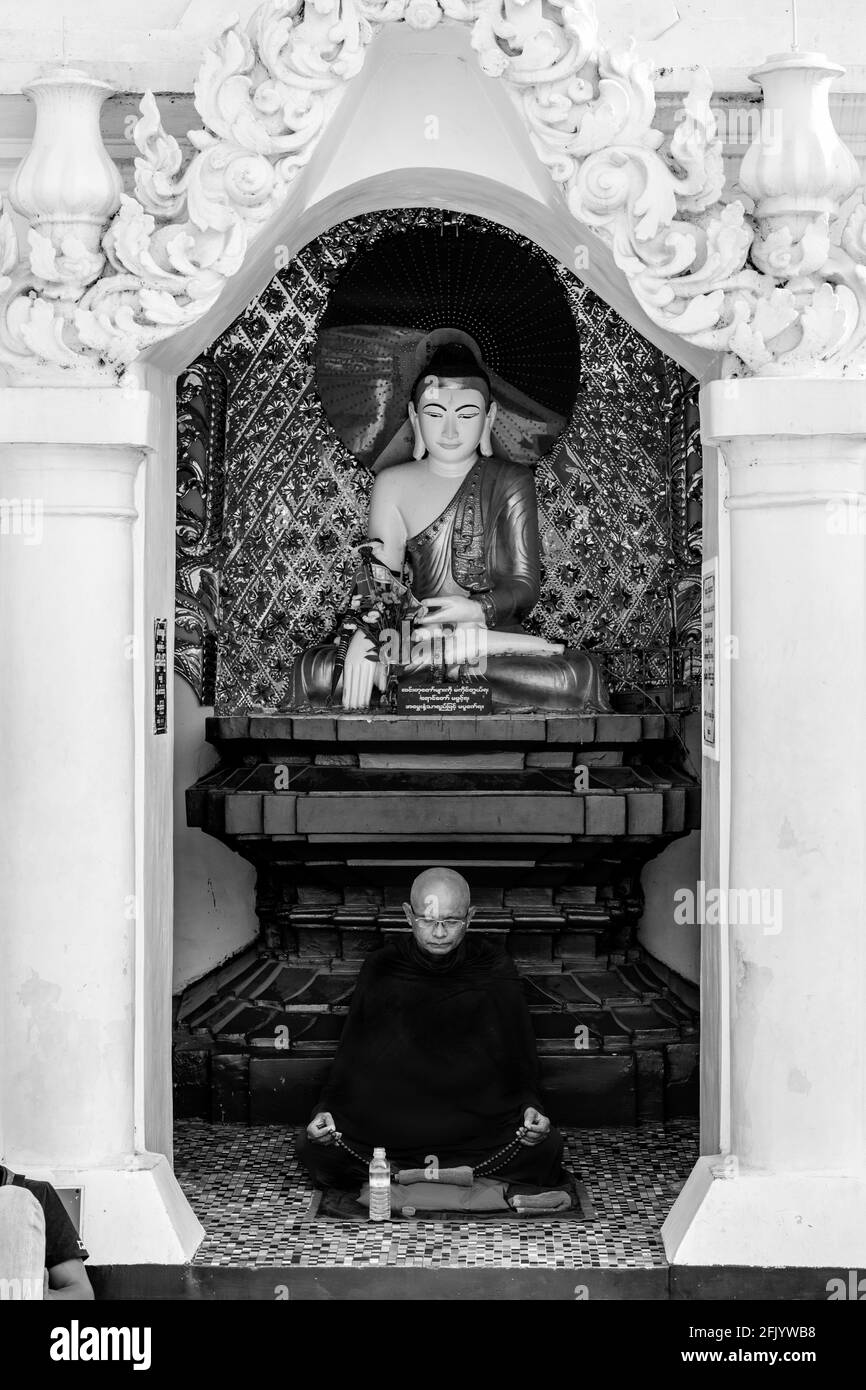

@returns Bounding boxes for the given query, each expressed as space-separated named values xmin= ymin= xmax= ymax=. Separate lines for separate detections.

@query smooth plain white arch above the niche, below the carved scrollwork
xmin=145 ymin=25 xmax=719 ymax=378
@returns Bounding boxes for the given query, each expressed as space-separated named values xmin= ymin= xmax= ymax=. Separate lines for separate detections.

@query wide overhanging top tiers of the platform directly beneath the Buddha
xmin=186 ymin=713 xmax=699 ymax=845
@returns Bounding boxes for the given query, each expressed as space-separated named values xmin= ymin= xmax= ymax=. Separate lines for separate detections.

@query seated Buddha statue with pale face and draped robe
xmin=281 ymin=342 xmax=610 ymax=713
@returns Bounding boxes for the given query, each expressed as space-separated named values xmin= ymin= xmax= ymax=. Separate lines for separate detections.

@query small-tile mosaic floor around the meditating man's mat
xmin=175 ymin=1120 xmax=698 ymax=1269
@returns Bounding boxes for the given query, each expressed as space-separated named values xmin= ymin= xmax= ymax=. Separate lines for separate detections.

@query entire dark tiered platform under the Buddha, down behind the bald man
xmin=175 ymin=712 xmax=699 ymax=1126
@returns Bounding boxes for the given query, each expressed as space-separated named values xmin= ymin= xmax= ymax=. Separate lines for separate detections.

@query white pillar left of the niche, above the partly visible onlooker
xmin=0 ymin=388 xmax=202 ymax=1264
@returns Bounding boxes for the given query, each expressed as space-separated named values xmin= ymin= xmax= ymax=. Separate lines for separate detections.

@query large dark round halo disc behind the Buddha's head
xmin=316 ymin=225 xmax=580 ymax=473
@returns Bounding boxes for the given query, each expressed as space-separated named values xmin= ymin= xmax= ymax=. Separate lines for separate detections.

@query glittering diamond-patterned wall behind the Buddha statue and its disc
xmin=177 ymin=209 xmax=701 ymax=713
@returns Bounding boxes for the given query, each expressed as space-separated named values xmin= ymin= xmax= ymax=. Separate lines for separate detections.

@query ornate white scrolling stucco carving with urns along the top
xmin=0 ymin=0 xmax=866 ymax=377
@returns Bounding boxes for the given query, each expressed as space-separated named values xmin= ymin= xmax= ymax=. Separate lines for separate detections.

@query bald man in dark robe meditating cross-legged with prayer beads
xmin=300 ymin=869 xmax=563 ymax=1188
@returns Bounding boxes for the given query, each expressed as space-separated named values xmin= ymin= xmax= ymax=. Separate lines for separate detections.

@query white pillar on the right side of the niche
xmin=664 ymin=378 xmax=866 ymax=1268
